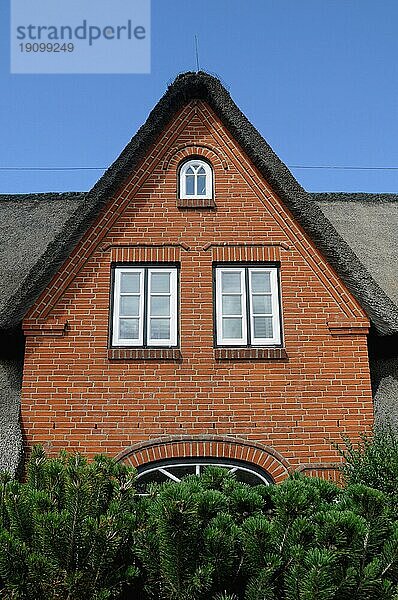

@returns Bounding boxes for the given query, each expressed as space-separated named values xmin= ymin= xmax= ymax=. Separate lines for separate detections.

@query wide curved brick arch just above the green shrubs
xmin=116 ymin=435 xmax=292 ymax=483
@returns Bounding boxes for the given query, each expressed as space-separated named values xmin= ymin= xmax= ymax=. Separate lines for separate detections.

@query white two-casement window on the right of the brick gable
xmin=216 ymin=266 xmax=281 ymax=346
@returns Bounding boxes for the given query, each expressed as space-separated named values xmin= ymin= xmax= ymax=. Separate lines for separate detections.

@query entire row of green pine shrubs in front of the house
xmin=0 ymin=448 xmax=398 ymax=600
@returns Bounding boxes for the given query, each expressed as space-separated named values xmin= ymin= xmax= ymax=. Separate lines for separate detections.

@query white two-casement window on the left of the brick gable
xmin=112 ymin=267 xmax=177 ymax=347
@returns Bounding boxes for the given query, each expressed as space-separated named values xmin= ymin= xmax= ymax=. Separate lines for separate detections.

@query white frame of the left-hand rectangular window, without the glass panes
xmin=112 ymin=266 xmax=178 ymax=348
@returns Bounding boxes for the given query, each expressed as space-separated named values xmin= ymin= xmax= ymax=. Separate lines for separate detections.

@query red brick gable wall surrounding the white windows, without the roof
xmin=22 ymin=102 xmax=372 ymax=472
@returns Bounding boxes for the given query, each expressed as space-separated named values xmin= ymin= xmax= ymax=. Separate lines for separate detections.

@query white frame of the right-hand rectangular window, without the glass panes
xmin=215 ymin=265 xmax=282 ymax=347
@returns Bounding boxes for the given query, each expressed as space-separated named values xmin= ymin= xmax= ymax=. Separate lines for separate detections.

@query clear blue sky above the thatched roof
xmin=0 ymin=0 xmax=398 ymax=193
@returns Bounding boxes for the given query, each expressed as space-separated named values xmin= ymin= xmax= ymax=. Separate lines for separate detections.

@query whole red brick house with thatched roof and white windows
xmin=0 ymin=73 xmax=398 ymax=482
